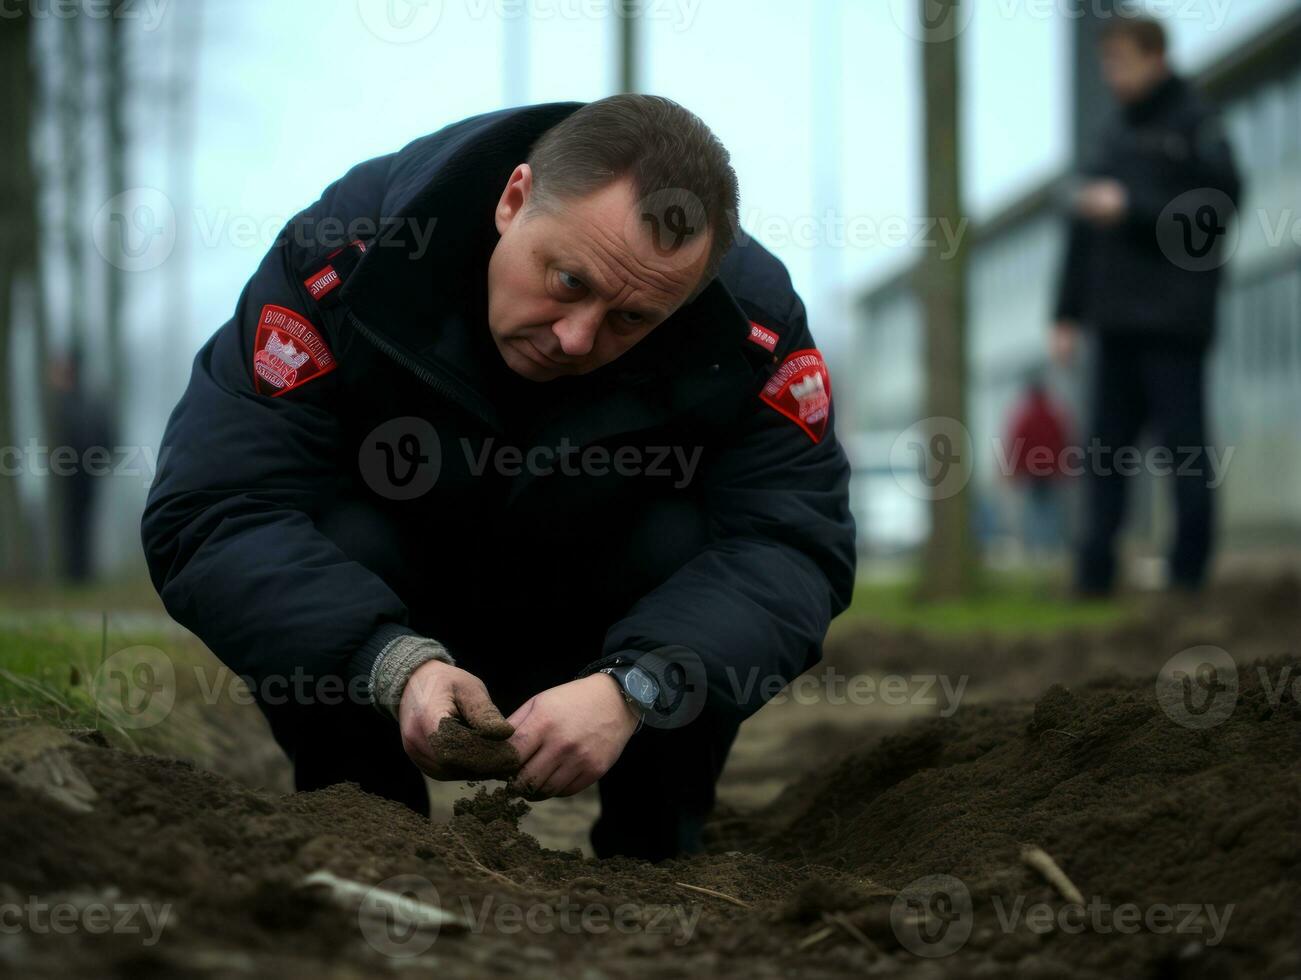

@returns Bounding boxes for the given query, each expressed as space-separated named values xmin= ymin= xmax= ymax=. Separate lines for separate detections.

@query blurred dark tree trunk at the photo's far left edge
xmin=0 ymin=3 xmax=36 ymax=578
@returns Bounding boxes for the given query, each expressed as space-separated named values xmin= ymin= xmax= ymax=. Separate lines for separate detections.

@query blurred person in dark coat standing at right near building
xmin=1051 ymin=17 xmax=1241 ymax=595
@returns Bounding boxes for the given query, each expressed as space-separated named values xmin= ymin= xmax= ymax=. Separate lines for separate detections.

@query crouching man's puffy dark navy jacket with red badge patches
xmin=142 ymin=103 xmax=855 ymax=718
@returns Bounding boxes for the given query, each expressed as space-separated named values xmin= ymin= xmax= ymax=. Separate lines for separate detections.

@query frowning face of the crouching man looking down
xmin=488 ymin=164 xmax=709 ymax=381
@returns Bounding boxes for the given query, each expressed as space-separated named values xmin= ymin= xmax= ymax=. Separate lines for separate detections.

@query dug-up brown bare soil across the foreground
xmin=0 ymin=579 xmax=1301 ymax=980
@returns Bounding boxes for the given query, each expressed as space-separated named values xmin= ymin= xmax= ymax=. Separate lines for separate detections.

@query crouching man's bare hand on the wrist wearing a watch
xmin=507 ymin=674 xmax=637 ymax=799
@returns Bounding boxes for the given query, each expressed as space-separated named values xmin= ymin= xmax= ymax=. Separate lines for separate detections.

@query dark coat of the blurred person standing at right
xmin=1056 ymin=75 xmax=1241 ymax=342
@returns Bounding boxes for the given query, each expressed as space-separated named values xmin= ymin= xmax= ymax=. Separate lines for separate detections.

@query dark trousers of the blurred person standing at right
xmin=1077 ymin=331 xmax=1216 ymax=593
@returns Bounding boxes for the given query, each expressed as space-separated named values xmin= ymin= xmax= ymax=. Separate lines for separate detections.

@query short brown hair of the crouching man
xmin=526 ymin=94 xmax=739 ymax=298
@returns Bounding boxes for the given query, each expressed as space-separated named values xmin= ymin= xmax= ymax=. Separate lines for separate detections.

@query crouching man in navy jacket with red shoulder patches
xmin=142 ymin=95 xmax=855 ymax=860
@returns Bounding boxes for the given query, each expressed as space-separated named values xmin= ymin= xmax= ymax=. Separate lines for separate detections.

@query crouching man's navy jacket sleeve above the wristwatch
xmin=588 ymin=299 xmax=855 ymax=728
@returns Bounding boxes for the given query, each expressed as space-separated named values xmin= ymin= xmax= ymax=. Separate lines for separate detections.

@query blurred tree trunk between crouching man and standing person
xmin=917 ymin=0 xmax=976 ymax=599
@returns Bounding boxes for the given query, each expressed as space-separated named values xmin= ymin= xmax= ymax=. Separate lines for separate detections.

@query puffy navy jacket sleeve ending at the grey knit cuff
xmin=141 ymin=212 xmax=426 ymax=701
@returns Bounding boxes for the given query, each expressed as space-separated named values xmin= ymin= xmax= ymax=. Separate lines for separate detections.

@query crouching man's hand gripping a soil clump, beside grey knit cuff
xmin=398 ymin=660 xmax=514 ymax=780
